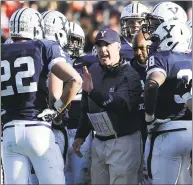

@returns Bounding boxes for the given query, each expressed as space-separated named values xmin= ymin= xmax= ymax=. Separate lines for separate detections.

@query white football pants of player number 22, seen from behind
xmin=3 ymin=120 xmax=64 ymax=184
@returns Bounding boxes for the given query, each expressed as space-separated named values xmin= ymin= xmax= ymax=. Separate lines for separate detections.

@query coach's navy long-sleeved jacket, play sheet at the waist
xmin=75 ymin=59 xmax=142 ymax=139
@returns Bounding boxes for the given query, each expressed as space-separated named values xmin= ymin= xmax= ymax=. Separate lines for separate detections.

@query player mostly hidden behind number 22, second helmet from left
xmin=38 ymin=10 xmax=71 ymax=184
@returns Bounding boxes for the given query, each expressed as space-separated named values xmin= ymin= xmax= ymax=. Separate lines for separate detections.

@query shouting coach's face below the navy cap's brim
xmin=96 ymin=40 xmax=121 ymax=65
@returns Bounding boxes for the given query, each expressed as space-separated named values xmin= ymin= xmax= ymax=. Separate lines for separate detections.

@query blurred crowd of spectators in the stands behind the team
xmin=1 ymin=0 xmax=192 ymax=53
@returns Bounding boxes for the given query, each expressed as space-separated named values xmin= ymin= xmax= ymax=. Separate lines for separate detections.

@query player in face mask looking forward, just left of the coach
xmin=65 ymin=22 xmax=93 ymax=184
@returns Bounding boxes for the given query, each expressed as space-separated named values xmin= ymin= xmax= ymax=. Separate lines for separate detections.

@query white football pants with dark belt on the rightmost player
xmin=145 ymin=121 xmax=192 ymax=185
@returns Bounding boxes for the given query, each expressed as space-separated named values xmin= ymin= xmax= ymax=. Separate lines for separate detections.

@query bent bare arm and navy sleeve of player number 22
xmin=42 ymin=41 xmax=82 ymax=113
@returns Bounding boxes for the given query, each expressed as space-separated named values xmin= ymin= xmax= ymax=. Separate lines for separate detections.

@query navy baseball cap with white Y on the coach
xmin=95 ymin=28 xmax=121 ymax=44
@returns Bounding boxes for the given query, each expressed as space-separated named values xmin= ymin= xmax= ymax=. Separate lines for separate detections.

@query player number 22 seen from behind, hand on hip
xmin=1 ymin=8 xmax=82 ymax=184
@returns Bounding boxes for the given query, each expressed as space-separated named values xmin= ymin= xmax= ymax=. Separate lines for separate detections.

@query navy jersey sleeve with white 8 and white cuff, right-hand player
xmin=146 ymin=55 xmax=167 ymax=77
